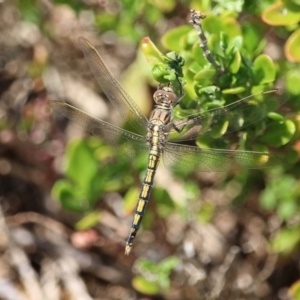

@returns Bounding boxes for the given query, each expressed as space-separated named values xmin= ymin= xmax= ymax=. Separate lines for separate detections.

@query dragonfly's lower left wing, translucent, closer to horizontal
xmin=49 ymin=100 xmax=149 ymax=157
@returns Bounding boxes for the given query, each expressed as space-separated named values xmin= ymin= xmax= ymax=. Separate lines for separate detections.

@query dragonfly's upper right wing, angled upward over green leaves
xmin=169 ymin=89 xmax=289 ymax=141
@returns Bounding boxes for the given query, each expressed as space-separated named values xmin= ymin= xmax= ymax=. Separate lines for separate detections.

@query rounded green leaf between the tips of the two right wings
xmin=260 ymin=120 xmax=296 ymax=147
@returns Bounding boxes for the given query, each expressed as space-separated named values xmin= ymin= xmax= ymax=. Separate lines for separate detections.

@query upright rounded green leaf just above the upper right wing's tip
xmin=252 ymin=54 xmax=276 ymax=84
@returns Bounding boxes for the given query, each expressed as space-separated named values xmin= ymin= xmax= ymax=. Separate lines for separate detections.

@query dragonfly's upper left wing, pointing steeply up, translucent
xmin=78 ymin=37 xmax=148 ymax=134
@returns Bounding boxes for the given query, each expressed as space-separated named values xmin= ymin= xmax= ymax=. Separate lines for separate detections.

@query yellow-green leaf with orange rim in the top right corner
xmin=262 ymin=1 xmax=300 ymax=26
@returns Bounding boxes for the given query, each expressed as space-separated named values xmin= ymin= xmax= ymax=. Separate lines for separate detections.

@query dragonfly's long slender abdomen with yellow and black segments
xmin=125 ymin=149 xmax=160 ymax=255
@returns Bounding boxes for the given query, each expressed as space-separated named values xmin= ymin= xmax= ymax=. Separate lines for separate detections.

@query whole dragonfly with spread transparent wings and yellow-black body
xmin=49 ymin=37 xmax=288 ymax=255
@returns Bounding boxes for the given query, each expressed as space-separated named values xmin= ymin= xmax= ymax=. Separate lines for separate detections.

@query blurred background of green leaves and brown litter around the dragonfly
xmin=0 ymin=0 xmax=300 ymax=300
